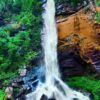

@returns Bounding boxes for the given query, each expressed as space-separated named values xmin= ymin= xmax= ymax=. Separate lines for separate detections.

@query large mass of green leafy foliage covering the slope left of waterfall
xmin=0 ymin=0 xmax=42 ymax=72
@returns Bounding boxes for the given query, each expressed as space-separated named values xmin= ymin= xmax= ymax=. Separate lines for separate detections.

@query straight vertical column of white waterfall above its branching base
xmin=42 ymin=0 xmax=60 ymax=84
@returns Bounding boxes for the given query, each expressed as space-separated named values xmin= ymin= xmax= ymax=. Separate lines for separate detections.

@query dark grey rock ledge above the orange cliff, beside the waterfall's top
xmin=56 ymin=0 xmax=88 ymax=16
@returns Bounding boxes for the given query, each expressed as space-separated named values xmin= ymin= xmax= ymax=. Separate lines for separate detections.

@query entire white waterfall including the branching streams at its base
xmin=26 ymin=0 xmax=89 ymax=100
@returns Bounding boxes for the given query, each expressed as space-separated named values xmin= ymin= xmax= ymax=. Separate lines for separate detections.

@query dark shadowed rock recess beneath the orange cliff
xmin=58 ymin=51 xmax=87 ymax=76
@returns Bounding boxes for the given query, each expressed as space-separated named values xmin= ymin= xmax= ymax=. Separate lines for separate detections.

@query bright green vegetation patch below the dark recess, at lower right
xmin=67 ymin=76 xmax=100 ymax=100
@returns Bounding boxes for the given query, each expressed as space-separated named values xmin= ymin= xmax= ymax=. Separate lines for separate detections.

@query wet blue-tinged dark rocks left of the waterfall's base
xmin=10 ymin=67 xmax=45 ymax=100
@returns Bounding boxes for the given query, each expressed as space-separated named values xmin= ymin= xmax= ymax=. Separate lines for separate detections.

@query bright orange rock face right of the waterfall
xmin=57 ymin=7 xmax=100 ymax=67
